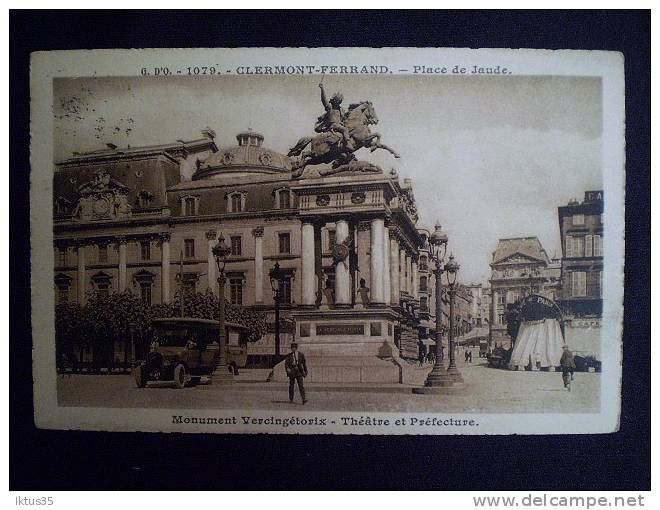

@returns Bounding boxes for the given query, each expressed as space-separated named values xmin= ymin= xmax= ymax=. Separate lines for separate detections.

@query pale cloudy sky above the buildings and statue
xmin=53 ymin=75 xmax=603 ymax=282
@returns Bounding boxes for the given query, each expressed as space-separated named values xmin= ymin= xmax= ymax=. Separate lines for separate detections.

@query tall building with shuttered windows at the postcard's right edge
xmin=558 ymin=190 xmax=603 ymax=317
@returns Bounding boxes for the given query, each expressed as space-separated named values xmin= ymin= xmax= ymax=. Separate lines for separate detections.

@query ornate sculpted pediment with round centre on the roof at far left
xmin=71 ymin=170 xmax=131 ymax=221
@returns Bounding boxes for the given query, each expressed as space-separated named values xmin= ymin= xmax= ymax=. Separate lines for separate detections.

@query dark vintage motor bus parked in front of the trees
xmin=133 ymin=317 xmax=247 ymax=388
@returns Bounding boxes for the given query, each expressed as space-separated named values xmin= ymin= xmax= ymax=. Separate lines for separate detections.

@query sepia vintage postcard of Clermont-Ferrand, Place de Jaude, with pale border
xmin=31 ymin=48 xmax=625 ymax=434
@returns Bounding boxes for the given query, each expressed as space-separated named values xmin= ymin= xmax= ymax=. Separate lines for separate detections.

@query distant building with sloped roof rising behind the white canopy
xmin=490 ymin=236 xmax=561 ymax=344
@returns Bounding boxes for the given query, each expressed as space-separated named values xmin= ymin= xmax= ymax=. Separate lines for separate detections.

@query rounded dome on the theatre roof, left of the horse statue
xmin=192 ymin=130 xmax=291 ymax=180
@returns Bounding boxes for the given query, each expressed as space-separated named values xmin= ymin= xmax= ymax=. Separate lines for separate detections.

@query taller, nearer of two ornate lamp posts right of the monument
xmin=415 ymin=223 xmax=454 ymax=393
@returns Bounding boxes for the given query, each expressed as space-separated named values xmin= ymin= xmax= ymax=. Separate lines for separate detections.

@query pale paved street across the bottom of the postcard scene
xmin=58 ymin=359 xmax=601 ymax=413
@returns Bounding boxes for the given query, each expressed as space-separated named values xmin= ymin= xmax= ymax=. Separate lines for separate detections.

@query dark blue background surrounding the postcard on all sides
xmin=10 ymin=11 xmax=651 ymax=490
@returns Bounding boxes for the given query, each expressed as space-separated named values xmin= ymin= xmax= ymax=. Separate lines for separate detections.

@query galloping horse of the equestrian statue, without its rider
xmin=287 ymin=101 xmax=399 ymax=177
